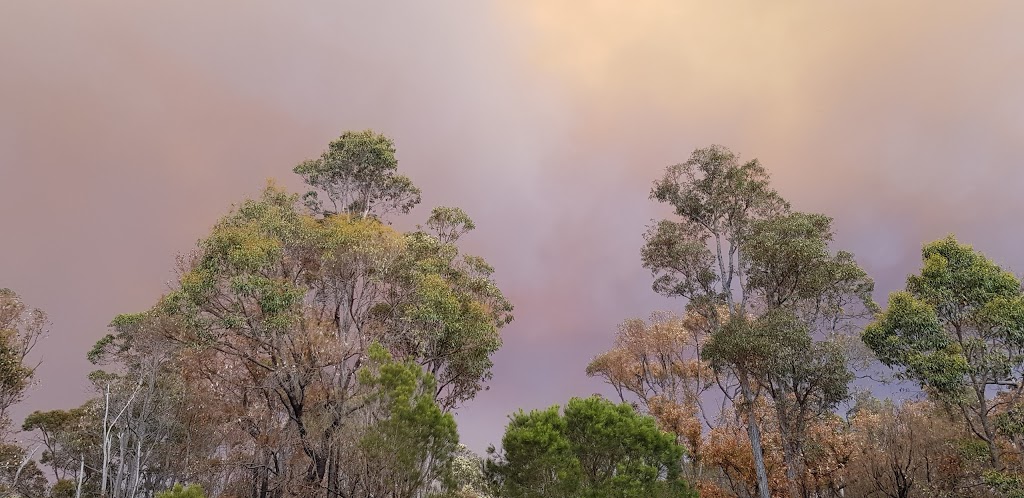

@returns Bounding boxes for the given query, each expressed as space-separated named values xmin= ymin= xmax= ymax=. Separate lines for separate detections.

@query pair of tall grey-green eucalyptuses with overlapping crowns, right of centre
xmin=642 ymin=146 xmax=873 ymax=498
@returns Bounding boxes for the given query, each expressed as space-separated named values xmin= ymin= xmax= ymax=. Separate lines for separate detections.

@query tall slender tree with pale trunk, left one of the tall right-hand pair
xmin=641 ymin=146 xmax=788 ymax=498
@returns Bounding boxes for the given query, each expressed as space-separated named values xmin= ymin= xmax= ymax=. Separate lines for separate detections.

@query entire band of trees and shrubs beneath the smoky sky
xmin=12 ymin=139 xmax=1024 ymax=498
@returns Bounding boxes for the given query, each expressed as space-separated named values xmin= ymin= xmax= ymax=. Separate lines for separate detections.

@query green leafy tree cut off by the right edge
xmin=863 ymin=236 xmax=1024 ymax=468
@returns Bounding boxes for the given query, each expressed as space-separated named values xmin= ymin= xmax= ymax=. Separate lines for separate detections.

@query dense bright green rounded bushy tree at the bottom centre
xmin=487 ymin=397 xmax=696 ymax=498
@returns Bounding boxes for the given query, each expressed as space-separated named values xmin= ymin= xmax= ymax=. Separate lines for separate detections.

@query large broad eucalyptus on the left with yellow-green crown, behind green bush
xmin=116 ymin=131 xmax=512 ymax=496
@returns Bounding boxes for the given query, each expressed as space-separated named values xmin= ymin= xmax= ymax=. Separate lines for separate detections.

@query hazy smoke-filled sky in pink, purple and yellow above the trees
xmin=0 ymin=0 xmax=1024 ymax=450
